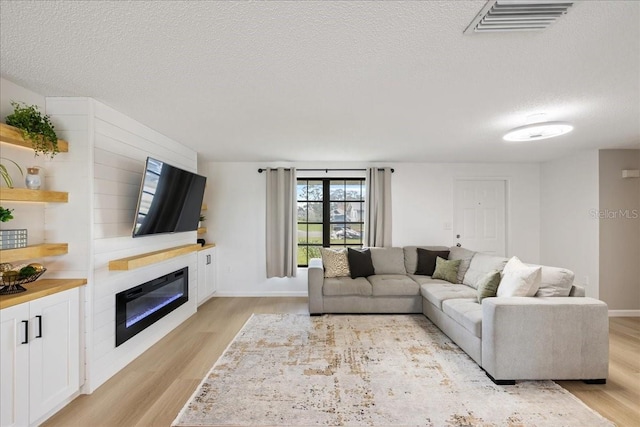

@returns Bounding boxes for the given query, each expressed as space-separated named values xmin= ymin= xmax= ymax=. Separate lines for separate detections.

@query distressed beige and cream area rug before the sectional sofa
xmin=173 ymin=314 xmax=613 ymax=427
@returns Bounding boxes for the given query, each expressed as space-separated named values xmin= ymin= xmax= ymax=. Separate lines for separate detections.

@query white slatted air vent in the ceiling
xmin=464 ymin=0 xmax=573 ymax=34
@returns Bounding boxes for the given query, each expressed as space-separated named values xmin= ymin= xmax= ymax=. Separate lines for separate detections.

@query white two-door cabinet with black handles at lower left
xmin=0 ymin=288 xmax=80 ymax=427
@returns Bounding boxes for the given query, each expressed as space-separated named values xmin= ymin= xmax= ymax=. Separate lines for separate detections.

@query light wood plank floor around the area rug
xmin=44 ymin=298 xmax=640 ymax=427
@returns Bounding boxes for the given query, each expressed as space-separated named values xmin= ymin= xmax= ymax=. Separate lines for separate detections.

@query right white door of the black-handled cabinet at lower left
xmin=29 ymin=289 xmax=80 ymax=423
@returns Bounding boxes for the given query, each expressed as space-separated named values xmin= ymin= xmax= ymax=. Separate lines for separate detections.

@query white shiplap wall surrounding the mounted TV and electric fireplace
xmin=47 ymin=98 xmax=197 ymax=392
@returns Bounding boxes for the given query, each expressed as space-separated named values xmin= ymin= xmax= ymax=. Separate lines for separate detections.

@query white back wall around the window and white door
xmin=205 ymin=162 xmax=540 ymax=296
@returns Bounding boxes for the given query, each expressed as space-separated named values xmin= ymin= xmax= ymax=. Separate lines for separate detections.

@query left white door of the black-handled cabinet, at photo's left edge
xmin=0 ymin=303 xmax=29 ymax=427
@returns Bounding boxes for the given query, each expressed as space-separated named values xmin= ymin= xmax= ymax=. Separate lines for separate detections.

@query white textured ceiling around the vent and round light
xmin=0 ymin=0 xmax=640 ymax=162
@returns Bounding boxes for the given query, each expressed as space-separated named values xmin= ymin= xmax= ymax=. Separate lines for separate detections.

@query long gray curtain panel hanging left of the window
xmin=266 ymin=168 xmax=298 ymax=278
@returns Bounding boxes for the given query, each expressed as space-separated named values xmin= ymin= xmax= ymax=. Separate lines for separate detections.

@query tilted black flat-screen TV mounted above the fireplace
xmin=133 ymin=157 xmax=207 ymax=237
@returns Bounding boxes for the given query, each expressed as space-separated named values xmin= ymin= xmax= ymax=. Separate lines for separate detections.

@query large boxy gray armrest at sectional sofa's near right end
xmin=482 ymin=297 xmax=609 ymax=381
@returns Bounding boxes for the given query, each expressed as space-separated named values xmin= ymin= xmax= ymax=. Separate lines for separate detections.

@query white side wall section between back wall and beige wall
xmin=540 ymin=150 xmax=599 ymax=298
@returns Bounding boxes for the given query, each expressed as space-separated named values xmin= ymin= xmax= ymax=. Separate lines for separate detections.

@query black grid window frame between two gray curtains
xmin=296 ymin=177 xmax=365 ymax=268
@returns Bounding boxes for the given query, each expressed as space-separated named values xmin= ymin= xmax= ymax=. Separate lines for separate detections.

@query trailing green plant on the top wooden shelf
xmin=6 ymin=101 xmax=59 ymax=158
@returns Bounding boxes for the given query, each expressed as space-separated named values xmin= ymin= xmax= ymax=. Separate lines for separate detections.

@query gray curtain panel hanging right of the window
xmin=365 ymin=168 xmax=392 ymax=247
